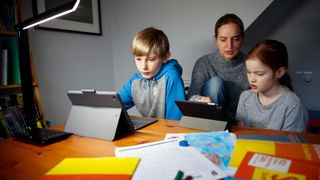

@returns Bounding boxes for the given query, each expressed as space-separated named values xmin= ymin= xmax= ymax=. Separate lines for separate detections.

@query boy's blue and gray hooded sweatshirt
xmin=119 ymin=59 xmax=185 ymax=120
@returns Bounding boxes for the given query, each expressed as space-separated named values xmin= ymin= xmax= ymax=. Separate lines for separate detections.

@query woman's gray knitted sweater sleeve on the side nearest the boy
xmin=187 ymin=57 xmax=210 ymax=99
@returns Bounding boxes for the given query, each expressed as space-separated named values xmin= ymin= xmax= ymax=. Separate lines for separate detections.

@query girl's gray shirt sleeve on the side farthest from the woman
xmin=282 ymin=101 xmax=309 ymax=132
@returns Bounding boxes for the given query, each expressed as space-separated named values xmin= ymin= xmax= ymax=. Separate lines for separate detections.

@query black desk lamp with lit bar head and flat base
xmin=16 ymin=0 xmax=80 ymax=145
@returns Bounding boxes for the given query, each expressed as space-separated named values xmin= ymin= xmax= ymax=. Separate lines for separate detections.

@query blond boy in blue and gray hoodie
xmin=119 ymin=27 xmax=185 ymax=120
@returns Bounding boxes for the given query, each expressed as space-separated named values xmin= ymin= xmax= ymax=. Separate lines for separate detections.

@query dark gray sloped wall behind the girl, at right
xmin=245 ymin=0 xmax=320 ymax=111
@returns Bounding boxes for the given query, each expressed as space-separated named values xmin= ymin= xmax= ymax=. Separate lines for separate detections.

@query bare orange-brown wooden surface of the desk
xmin=0 ymin=120 xmax=320 ymax=179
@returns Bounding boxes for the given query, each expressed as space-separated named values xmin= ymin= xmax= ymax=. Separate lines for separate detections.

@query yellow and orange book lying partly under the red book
xmin=229 ymin=139 xmax=320 ymax=168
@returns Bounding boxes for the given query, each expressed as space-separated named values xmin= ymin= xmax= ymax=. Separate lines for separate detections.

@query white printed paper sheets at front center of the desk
xmin=115 ymin=139 xmax=227 ymax=180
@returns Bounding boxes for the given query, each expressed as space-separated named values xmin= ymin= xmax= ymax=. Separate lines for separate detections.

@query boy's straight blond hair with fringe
xmin=131 ymin=27 xmax=170 ymax=59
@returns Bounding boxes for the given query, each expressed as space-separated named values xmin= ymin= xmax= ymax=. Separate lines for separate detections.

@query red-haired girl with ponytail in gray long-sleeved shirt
xmin=236 ymin=40 xmax=308 ymax=131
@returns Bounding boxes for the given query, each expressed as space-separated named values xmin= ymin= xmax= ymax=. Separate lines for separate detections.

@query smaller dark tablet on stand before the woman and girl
xmin=176 ymin=100 xmax=228 ymax=131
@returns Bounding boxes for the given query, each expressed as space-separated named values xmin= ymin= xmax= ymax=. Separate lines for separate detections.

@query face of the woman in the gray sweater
xmin=215 ymin=23 xmax=243 ymax=60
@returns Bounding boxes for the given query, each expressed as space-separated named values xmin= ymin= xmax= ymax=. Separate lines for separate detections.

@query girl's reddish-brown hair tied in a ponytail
xmin=245 ymin=39 xmax=293 ymax=91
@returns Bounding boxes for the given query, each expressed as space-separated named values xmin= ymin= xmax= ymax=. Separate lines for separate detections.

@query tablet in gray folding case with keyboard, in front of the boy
xmin=65 ymin=89 xmax=157 ymax=141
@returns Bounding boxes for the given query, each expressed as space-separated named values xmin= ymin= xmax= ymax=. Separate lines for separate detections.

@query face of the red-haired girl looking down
xmin=246 ymin=58 xmax=285 ymax=94
